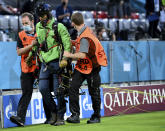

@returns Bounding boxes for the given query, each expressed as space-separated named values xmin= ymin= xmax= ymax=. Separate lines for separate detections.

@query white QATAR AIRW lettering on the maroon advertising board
xmin=104 ymin=88 xmax=165 ymax=111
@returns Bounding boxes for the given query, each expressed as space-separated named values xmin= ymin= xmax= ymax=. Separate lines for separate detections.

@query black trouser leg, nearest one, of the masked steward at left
xmin=17 ymin=72 xmax=35 ymax=122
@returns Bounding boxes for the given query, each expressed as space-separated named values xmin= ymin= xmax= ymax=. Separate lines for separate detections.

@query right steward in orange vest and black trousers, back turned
xmin=64 ymin=12 xmax=107 ymax=124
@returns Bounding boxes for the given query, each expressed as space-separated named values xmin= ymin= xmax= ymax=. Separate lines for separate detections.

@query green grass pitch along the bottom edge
xmin=0 ymin=111 xmax=165 ymax=131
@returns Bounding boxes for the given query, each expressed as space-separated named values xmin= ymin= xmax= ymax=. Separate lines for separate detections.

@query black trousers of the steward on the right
xmin=69 ymin=67 xmax=101 ymax=117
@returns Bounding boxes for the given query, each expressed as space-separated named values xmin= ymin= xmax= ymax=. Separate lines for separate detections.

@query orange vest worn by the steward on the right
xmin=74 ymin=27 xmax=107 ymax=74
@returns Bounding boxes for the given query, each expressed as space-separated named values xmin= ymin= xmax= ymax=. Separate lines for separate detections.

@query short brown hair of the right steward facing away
xmin=71 ymin=12 xmax=84 ymax=26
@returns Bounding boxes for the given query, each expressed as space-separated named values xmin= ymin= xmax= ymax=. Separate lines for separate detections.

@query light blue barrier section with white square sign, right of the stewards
xmin=100 ymin=41 xmax=165 ymax=83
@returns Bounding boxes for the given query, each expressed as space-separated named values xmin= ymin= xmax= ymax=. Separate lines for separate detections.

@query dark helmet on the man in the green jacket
xmin=36 ymin=3 xmax=51 ymax=17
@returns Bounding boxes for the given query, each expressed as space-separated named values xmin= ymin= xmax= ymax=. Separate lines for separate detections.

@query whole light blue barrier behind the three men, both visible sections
xmin=0 ymin=41 xmax=165 ymax=89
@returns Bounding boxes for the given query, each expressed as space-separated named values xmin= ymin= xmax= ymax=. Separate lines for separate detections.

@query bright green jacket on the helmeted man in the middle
xmin=36 ymin=18 xmax=71 ymax=63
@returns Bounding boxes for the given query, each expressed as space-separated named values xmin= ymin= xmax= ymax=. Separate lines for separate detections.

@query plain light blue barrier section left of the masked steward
xmin=0 ymin=42 xmax=21 ymax=89
